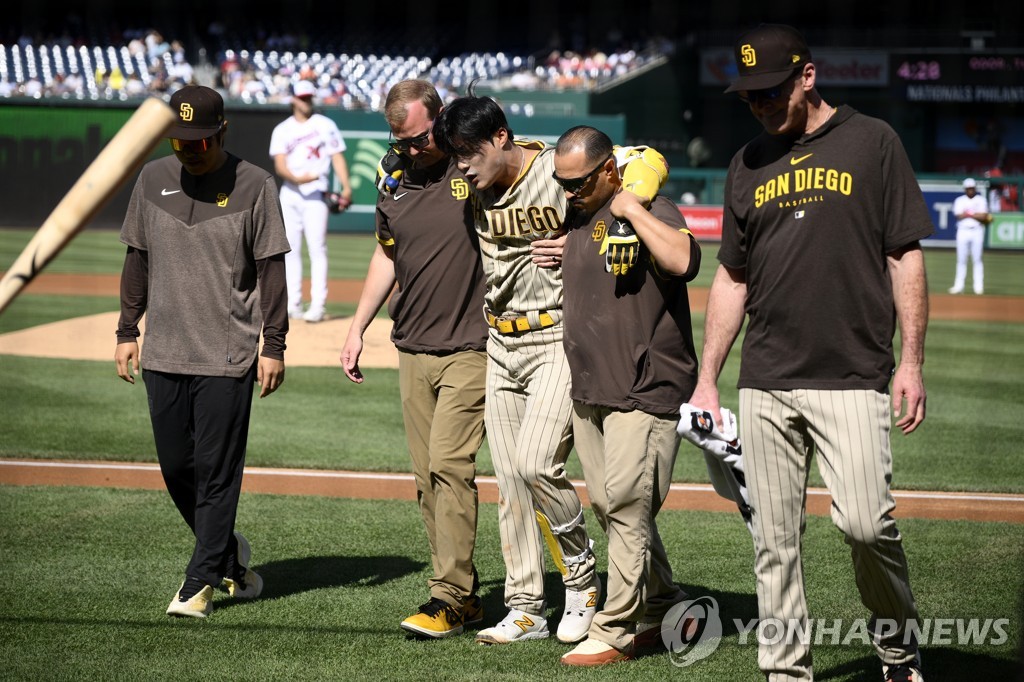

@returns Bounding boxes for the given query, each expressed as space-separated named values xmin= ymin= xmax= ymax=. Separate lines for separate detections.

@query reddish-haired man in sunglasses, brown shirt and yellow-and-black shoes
xmin=341 ymin=80 xmax=487 ymax=639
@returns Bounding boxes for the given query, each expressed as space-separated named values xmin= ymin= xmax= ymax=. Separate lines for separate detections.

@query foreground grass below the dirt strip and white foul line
xmin=0 ymin=487 xmax=1022 ymax=682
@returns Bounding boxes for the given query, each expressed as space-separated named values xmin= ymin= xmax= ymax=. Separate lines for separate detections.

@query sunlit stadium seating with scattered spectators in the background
xmin=0 ymin=26 xmax=657 ymax=111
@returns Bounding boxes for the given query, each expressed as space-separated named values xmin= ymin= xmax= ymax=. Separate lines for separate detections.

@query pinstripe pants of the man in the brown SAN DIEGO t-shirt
xmin=739 ymin=388 xmax=918 ymax=682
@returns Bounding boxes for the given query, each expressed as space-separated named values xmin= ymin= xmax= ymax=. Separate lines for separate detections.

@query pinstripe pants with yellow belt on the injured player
xmin=484 ymin=324 xmax=596 ymax=615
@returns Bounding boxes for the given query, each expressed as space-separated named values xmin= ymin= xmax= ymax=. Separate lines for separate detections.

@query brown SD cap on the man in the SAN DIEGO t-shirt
xmin=725 ymin=24 xmax=811 ymax=92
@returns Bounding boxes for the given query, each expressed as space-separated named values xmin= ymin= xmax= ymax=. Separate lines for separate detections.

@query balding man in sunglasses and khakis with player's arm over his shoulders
xmin=554 ymin=126 xmax=700 ymax=666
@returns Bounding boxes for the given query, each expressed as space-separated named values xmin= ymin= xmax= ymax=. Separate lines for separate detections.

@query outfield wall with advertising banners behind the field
xmin=0 ymin=100 xmax=1024 ymax=249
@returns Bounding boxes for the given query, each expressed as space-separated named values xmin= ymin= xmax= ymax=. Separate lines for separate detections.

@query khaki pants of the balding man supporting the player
xmin=572 ymin=401 xmax=686 ymax=650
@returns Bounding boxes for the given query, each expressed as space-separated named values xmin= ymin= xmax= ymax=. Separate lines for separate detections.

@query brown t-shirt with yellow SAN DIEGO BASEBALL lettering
xmin=718 ymin=106 xmax=934 ymax=391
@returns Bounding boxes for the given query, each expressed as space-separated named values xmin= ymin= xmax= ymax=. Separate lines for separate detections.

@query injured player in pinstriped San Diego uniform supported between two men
xmin=433 ymin=89 xmax=656 ymax=644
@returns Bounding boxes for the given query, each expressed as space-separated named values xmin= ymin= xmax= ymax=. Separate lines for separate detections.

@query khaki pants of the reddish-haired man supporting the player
xmin=398 ymin=350 xmax=486 ymax=606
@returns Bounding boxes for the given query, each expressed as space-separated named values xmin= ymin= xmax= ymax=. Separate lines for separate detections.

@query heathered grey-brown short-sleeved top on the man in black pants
xmin=121 ymin=155 xmax=289 ymax=377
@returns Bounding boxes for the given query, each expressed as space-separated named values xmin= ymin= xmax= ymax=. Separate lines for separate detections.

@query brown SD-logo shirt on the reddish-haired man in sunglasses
xmin=377 ymin=155 xmax=487 ymax=353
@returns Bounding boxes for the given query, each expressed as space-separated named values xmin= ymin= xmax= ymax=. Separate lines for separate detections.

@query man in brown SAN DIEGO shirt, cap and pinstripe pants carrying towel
xmin=688 ymin=25 xmax=933 ymax=682
